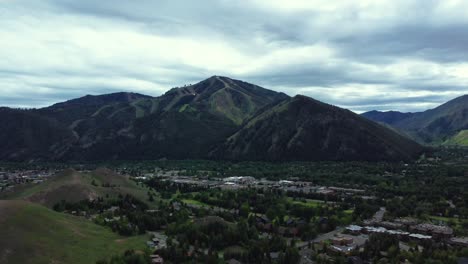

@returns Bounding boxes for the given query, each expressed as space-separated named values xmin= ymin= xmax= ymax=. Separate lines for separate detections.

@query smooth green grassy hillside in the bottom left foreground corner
xmin=0 ymin=201 xmax=147 ymax=264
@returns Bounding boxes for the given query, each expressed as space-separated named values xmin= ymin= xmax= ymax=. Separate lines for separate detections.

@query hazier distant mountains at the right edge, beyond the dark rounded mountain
xmin=363 ymin=95 xmax=468 ymax=144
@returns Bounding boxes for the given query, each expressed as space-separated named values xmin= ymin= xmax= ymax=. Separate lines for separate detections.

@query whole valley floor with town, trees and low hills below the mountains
xmin=0 ymin=149 xmax=468 ymax=263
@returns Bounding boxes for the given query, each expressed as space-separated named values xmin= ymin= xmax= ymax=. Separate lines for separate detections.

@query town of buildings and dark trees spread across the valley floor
xmin=0 ymin=156 xmax=468 ymax=263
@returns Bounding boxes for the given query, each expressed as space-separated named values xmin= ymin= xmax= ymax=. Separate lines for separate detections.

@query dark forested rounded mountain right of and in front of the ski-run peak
xmin=214 ymin=96 xmax=421 ymax=161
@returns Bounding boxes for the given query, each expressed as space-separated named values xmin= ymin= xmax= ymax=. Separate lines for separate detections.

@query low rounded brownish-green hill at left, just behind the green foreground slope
xmin=2 ymin=169 xmax=152 ymax=207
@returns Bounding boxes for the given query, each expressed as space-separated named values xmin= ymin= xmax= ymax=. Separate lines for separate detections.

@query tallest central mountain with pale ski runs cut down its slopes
xmin=54 ymin=76 xmax=287 ymax=160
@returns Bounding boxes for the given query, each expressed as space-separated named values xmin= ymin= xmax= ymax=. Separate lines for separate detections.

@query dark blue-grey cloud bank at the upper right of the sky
xmin=334 ymin=24 xmax=468 ymax=64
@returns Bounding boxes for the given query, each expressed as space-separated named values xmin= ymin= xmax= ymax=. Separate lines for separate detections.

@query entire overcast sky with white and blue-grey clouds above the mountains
xmin=0 ymin=0 xmax=468 ymax=112
